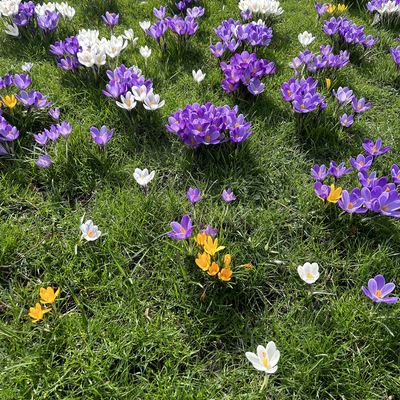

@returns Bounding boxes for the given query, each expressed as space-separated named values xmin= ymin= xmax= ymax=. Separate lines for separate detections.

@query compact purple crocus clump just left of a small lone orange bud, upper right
xmin=281 ymin=76 xmax=327 ymax=114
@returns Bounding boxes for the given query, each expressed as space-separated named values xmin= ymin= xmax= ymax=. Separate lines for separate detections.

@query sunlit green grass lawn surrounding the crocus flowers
xmin=0 ymin=0 xmax=400 ymax=400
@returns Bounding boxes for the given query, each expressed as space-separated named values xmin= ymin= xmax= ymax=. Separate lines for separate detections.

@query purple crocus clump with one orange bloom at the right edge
xmin=311 ymin=139 xmax=400 ymax=218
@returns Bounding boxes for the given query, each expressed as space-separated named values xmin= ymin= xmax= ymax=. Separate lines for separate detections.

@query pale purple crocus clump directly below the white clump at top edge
xmin=210 ymin=18 xmax=272 ymax=57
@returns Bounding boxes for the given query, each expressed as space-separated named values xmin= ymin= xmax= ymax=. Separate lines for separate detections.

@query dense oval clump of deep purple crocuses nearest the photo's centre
xmin=165 ymin=103 xmax=253 ymax=149
